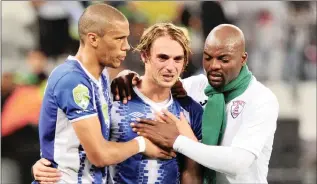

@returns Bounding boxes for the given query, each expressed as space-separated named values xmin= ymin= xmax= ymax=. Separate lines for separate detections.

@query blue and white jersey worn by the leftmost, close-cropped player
xmin=39 ymin=56 xmax=112 ymax=184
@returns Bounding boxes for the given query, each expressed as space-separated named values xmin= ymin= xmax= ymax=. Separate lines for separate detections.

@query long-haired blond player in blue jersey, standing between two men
xmin=110 ymin=23 xmax=202 ymax=184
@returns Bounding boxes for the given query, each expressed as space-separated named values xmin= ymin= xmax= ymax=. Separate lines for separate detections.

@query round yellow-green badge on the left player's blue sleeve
xmin=73 ymin=84 xmax=90 ymax=110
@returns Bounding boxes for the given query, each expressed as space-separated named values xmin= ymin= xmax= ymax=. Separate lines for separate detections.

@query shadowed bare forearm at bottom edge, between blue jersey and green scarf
xmin=181 ymin=158 xmax=202 ymax=184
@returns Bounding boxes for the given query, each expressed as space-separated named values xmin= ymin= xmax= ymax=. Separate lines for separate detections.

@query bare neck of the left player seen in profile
xmin=75 ymin=45 xmax=104 ymax=80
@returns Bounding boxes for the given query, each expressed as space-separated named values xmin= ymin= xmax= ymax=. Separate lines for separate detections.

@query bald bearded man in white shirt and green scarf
xmin=132 ymin=24 xmax=279 ymax=184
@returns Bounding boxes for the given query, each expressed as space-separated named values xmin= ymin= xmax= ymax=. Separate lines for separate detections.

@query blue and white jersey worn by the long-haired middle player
xmin=109 ymin=87 xmax=203 ymax=184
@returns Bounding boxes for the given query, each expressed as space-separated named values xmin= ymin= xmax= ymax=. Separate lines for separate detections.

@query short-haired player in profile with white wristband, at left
xmin=34 ymin=4 xmax=166 ymax=183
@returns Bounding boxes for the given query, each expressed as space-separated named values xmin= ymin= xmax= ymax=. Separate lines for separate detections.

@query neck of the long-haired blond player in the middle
xmin=137 ymin=76 xmax=171 ymax=102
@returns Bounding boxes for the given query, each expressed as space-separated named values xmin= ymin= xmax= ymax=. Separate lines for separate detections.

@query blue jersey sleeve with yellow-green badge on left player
xmin=54 ymin=72 xmax=97 ymax=122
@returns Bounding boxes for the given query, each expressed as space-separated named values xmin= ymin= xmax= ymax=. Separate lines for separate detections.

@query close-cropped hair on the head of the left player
xmin=78 ymin=4 xmax=128 ymax=44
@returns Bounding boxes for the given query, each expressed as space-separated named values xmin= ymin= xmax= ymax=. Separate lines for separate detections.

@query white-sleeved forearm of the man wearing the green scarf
xmin=173 ymin=136 xmax=255 ymax=175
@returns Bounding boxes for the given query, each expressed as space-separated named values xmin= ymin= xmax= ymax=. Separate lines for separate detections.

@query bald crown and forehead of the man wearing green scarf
xmin=206 ymin=24 xmax=245 ymax=52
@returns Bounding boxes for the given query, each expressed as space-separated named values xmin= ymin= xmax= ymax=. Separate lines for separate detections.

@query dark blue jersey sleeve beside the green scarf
xmin=177 ymin=96 xmax=203 ymax=141
